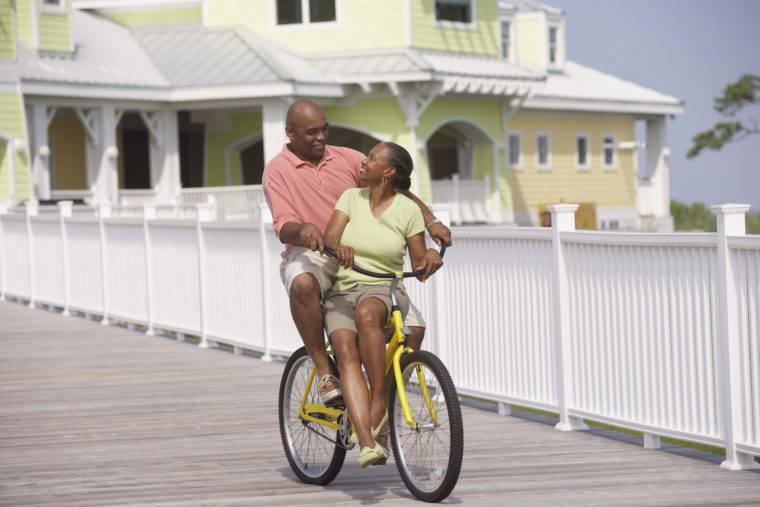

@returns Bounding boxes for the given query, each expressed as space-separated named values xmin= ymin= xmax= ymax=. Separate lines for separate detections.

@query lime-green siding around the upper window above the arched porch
xmin=412 ymin=0 xmax=499 ymax=56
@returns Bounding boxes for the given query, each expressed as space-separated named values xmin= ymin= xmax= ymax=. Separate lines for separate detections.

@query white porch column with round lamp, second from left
xmin=91 ymin=106 xmax=119 ymax=205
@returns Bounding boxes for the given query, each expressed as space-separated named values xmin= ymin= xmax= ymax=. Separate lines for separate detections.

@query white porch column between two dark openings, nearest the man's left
xmin=150 ymin=109 xmax=182 ymax=204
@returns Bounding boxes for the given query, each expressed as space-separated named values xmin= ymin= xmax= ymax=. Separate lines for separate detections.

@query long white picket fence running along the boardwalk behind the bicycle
xmin=0 ymin=204 xmax=760 ymax=469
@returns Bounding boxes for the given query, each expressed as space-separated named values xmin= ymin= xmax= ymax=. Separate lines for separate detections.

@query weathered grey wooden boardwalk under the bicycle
xmin=0 ymin=302 xmax=760 ymax=507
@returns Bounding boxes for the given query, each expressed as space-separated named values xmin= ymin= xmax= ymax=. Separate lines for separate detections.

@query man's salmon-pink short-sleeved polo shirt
xmin=263 ymin=145 xmax=366 ymax=257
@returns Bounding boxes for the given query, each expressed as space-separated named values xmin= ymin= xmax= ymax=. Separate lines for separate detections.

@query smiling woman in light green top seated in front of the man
xmin=325 ymin=143 xmax=425 ymax=467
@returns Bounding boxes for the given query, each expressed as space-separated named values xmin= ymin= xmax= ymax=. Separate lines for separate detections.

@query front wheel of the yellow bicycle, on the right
xmin=389 ymin=351 xmax=464 ymax=502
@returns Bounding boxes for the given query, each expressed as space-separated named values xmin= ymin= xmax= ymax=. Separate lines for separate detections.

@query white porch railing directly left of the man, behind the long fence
xmin=178 ymin=185 xmax=264 ymax=222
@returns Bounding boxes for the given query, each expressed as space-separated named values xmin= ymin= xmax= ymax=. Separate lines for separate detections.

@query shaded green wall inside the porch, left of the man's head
xmin=206 ymin=113 xmax=262 ymax=187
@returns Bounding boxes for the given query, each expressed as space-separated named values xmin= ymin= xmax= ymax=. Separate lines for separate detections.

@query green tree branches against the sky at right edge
xmin=686 ymin=74 xmax=760 ymax=158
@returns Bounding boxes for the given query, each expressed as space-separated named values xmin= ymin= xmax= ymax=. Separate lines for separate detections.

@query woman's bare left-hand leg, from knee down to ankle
xmin=330 ymin=329 xmax=375 ymax=448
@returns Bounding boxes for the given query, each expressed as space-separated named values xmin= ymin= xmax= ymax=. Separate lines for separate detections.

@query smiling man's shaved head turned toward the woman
xmin=285 ymin=99 xmax=329 ymax=166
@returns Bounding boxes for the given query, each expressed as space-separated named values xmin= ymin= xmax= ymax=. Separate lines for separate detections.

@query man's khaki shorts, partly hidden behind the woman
xmin=280 ymin=246 xmax=427 ymax=327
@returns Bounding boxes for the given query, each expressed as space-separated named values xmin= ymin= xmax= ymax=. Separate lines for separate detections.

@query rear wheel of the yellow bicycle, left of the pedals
xmin=278 ymin=347 xmax=346 ymax=486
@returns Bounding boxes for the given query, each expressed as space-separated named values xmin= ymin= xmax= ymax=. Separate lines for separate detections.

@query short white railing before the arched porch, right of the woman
xmin=430 ymin=174 xmax=491 ymax=225
